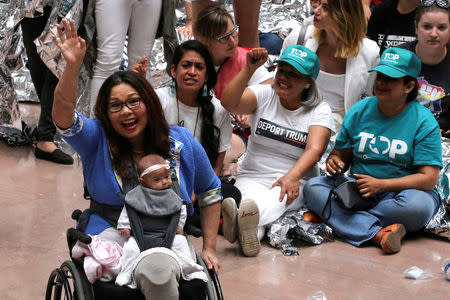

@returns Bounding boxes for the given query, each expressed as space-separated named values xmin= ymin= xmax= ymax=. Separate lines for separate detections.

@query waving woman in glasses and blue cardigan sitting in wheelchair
xmin=52 ymin=20 xmax=221 ymax=299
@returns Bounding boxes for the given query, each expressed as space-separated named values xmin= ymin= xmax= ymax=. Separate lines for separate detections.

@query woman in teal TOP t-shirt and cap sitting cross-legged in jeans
xmin=303 ymin=48 xmax=442 ymax=253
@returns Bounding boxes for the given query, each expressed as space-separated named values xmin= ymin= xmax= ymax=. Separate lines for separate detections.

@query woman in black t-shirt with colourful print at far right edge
xmin=400 ymin=1 xmax=450 ymax=137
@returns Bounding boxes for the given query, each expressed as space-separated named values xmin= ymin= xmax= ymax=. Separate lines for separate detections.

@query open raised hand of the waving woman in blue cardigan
xmin=53 ymin=19 xmax=86 ymax=66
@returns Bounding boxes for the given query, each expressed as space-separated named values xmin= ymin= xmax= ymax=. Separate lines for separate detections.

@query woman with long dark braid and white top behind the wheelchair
xmin=156 ymin=40 xmax=232 ymax=175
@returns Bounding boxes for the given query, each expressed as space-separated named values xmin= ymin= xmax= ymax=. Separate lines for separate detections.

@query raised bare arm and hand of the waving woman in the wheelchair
xmin=52 ymin=19 xmax=86 ymax=128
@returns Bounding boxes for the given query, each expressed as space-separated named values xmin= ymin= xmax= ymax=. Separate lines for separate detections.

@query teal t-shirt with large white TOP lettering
xmin=336 ymin=97 xmax=442 ymax=179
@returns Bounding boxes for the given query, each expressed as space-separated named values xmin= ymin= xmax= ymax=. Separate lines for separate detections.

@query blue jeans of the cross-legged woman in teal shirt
xmin=303 ymin=176 xmax=440 ymax=246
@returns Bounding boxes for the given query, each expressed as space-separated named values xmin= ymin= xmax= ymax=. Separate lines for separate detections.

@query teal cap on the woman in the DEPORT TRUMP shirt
xmin=274 ymin=45 xmax=320 ymax=79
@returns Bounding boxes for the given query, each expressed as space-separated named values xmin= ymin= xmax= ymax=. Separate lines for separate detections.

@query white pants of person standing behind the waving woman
xmin=90 ymin=0 xmax=162 ymax=112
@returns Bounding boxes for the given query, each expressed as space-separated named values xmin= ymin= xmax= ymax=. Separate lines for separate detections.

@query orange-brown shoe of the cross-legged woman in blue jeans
xmin=372 ymin=224 xmax=406 ymax=253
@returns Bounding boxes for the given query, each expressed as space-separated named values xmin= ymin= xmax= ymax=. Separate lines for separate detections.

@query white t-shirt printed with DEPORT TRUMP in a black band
xmin=238 ymin=84 xmax=334 ymax=184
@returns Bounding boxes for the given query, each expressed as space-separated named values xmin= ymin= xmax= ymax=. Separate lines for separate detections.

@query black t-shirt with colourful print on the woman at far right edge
xmin=400 ymin=41 xmax=450 ymax=130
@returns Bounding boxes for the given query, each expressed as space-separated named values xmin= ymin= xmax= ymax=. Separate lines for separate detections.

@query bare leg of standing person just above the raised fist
xmin=233 ymin=0 xmax=262 ymax=48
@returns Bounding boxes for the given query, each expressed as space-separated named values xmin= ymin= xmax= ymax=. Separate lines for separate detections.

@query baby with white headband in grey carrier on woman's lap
xmin=116 ymin=154 xmax=206 ymax=288
